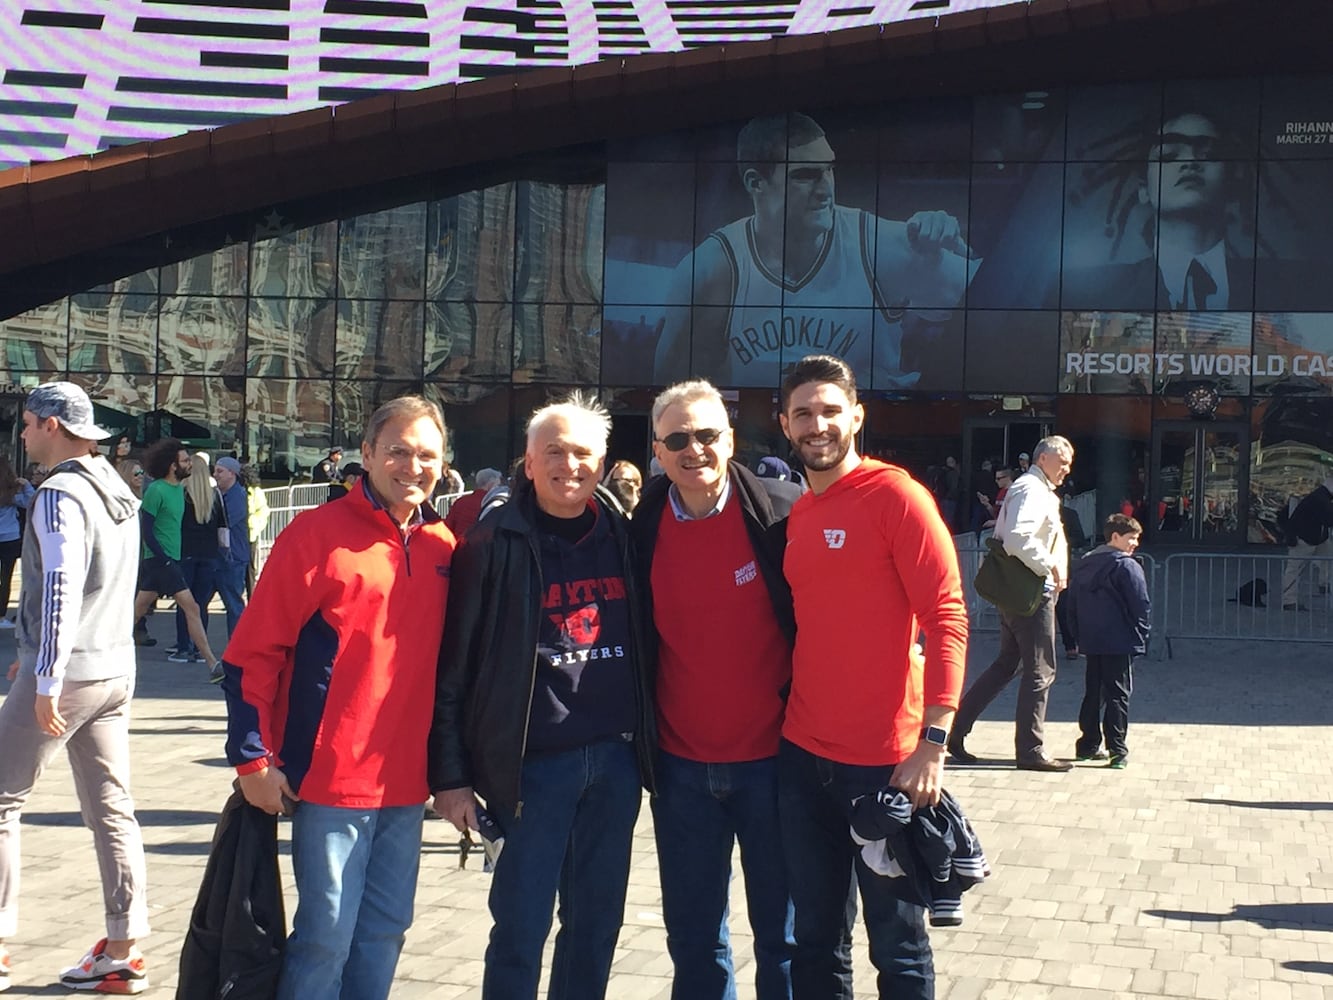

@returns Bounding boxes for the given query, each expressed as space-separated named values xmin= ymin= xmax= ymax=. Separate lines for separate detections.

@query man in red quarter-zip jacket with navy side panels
xmin=223 ymin=396 xmax=455 ymax=1000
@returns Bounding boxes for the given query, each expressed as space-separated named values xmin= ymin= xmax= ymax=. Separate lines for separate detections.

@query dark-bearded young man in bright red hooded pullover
xmin=778 ymin=355 xmax=968 ymax=1000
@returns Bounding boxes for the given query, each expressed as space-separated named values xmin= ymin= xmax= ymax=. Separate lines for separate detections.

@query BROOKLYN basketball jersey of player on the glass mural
xmin=709 ymin=205 xmax=901 ymax=388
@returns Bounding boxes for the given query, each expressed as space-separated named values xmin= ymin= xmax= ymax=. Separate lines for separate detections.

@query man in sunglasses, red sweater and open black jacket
xmin=631 ymin=380 xmax=800 ymax=1000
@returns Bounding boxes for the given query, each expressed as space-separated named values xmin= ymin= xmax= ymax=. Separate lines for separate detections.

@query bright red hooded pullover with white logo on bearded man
xmin=782 ymin=459 xmax=968 ymax=765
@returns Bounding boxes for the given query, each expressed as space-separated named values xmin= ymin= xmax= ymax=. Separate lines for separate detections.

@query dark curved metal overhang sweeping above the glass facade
xmin=0 ymin=0 xmax=1333 ymax=289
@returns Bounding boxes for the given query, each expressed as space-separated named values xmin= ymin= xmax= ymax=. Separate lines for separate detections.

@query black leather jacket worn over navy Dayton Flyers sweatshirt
xmin=427 ymin=477 xmax=657 ymax=811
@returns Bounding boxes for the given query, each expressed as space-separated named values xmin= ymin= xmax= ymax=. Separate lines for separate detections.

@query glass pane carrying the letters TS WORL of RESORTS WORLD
xmin=1154 ymin=312 xmax=1253 ymax=396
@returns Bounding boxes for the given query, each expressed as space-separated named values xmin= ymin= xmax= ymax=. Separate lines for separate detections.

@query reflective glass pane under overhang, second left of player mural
xmin=425 ymin=184 xmax=515 ymax=303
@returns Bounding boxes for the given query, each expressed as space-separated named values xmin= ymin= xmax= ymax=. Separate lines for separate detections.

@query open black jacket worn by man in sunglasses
xmin=629 ymin=461 xmax=796 ymax=653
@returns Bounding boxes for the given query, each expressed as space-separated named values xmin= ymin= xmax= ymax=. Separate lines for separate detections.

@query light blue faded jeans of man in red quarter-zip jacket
xmin=277 ymin=803 xmax=424 ymax=1000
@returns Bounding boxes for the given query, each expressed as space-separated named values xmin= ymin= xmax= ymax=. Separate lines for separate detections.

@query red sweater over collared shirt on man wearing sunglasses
xmin=652 ymin=501 xmax=792 ymax=764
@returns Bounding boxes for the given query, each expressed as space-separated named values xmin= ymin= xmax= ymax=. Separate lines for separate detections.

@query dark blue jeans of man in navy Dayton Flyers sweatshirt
xmin=481 ymin=740 xmax=643 ymax=1000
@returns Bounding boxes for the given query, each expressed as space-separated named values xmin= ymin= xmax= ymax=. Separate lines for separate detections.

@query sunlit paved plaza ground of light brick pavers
xmin=0 ymin=615 xmax=1333 ymax=1000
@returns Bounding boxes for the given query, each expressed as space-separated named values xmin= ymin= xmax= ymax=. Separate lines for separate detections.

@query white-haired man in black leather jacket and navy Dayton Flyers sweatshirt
xmin=428 ymin=393 xmax=656 ymax=1000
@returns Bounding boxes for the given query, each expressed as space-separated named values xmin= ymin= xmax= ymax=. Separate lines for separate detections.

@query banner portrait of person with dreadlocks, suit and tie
xmin=1061 ymin=95 xmax=1256 ymax=312
